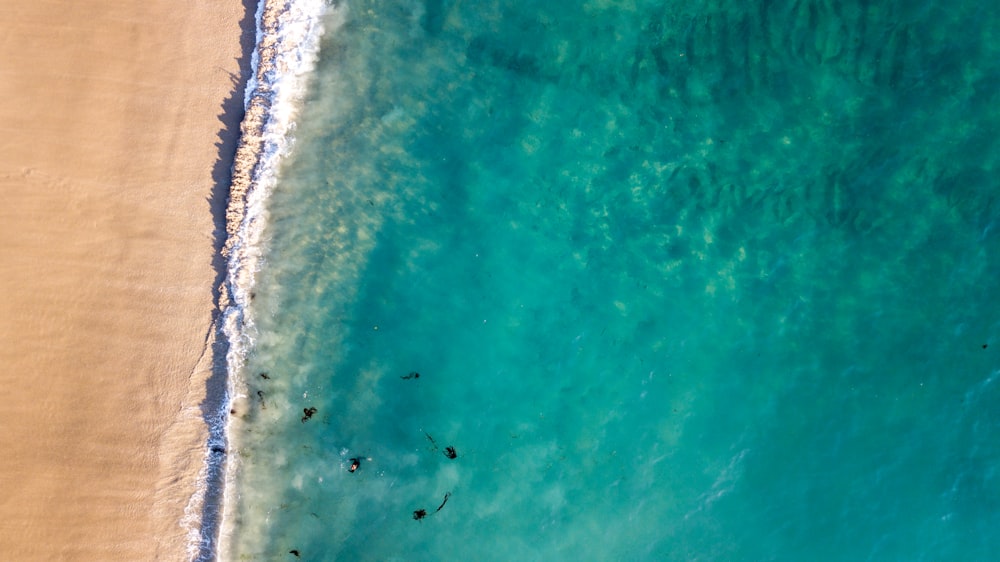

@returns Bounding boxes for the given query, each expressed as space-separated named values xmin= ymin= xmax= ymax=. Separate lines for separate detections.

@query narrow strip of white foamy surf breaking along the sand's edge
xmin=182 ymin=0 xmax=336 ymax=560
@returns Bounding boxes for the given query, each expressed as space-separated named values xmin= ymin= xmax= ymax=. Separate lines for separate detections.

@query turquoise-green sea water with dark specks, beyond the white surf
xmin=230 ymin=0 xmax=1000 ymax=561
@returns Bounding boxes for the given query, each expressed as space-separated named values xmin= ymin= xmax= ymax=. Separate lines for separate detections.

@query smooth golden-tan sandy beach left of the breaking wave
xmin=0 ymin=0 xmax=255 ymax=560
